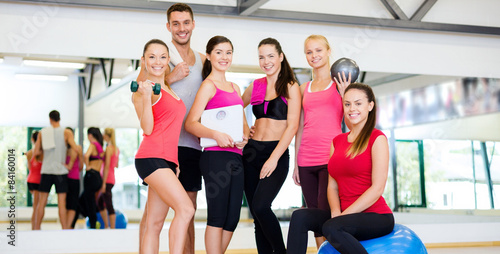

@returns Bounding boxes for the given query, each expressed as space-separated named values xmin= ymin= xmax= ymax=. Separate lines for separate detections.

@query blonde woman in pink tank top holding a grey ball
xmin=293 ymin=35 xmax=351 ymax=247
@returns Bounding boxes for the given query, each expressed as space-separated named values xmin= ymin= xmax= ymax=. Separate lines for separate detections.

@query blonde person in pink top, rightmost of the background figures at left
xmin=97 ymin=128 xmax=120 ymax=228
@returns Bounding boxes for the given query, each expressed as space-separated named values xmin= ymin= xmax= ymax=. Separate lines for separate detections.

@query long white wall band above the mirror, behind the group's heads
xmin=0 ymin=3 xmax=500 ymax=77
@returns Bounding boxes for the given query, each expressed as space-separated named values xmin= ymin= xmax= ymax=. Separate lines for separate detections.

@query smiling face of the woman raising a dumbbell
xmin=142 ymin=43 xmax=170 ymax=77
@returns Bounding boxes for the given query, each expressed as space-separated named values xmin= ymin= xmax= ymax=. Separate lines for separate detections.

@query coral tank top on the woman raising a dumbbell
xmin=135 ymin=89 xmax=186 ymax=165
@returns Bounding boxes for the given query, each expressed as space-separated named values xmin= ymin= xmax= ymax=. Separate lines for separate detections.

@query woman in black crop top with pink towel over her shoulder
xmin=242 ymin=38 xmax=301 ymax=253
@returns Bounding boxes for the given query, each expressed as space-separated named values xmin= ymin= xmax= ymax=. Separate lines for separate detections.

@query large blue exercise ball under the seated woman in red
xmin=318 ymin=224 xmax=427 ymax=254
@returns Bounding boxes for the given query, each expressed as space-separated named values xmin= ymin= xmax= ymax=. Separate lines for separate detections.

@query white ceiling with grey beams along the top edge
xmin=3 ymin=0 xmax=500 ymax=36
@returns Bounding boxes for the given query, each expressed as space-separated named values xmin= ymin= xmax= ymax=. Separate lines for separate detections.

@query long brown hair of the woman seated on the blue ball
xmin=344 ymin=83 xmax=377 ymax=159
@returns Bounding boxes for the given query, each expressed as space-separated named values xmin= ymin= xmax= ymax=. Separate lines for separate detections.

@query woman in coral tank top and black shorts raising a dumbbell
xmin=132 ymin=39 xmax=194 ymax=254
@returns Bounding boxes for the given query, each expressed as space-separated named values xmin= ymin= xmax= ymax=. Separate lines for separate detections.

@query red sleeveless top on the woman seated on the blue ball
xmin=328 ymin=129 xmax=392 ymax=214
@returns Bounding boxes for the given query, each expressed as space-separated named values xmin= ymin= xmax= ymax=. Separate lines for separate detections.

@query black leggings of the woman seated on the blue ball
xmin=287 ymin=209 xmax=394 ymax=254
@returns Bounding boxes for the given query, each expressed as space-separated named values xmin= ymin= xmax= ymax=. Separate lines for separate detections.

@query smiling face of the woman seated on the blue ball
xmin=343 ymin=89 xmax=374 ymax=126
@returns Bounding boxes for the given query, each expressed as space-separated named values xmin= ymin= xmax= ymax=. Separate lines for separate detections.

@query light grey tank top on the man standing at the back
xmin=170 ymin=50 xmax=203 ymax=150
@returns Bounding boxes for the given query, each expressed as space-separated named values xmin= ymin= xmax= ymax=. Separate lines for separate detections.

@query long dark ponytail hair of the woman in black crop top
xmin=258 ymin=38 xmax=297 ymax=98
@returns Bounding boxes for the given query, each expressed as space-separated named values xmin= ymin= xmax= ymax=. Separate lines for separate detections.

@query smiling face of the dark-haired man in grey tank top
xmin=167 ymin=11 xmax=195 ymax=45
